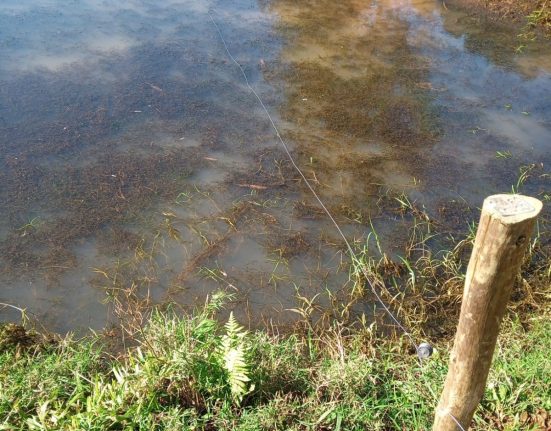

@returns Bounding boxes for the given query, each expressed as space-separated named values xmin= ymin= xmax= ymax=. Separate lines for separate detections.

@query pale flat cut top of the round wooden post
xmin=482 ymin=195 xmax=543 ymax=224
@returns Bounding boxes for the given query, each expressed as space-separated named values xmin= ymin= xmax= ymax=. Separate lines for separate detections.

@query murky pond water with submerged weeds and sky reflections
xmin=0 ymin=0 xmax=551 ymax=331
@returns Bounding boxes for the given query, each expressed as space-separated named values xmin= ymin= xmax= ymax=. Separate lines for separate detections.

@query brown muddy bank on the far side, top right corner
xmin=445 ymin=0 xmax=551 ymax=36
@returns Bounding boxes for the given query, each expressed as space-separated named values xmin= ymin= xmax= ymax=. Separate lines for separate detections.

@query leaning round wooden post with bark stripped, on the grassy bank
xmin=433 ymin=195 xmax=542 ymax=431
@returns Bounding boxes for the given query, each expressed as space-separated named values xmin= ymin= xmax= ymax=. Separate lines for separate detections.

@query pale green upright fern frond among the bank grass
xmin=220 ymin=312 xmax=254 ymax=404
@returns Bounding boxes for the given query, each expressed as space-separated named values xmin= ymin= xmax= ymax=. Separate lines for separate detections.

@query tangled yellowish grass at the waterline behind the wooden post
xmin=351 ymin=190 xmax=551 ymax=339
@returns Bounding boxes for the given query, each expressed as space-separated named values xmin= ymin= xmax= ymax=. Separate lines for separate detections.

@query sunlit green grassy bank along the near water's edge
xmin=0 ymin=295 xmax=551 ymax=430
